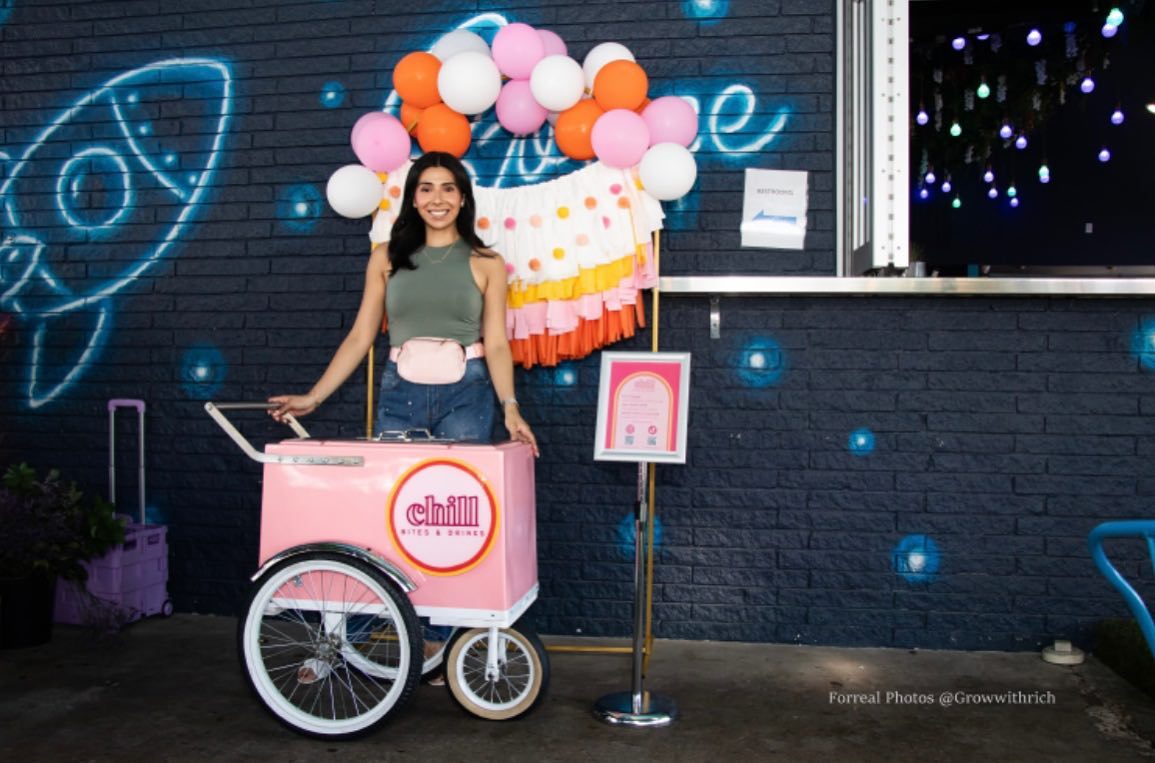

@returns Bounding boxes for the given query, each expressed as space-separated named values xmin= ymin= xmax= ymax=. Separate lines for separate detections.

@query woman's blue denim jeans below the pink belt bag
xmin=375 ymin=358 xmax=497 ymax=442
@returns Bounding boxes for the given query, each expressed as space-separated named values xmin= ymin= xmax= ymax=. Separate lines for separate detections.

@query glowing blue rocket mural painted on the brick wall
xmin=0 ymin=58 xmax=232 ymax=409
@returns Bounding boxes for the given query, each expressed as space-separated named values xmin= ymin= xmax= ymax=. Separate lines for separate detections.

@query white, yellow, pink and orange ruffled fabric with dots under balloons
xmin=370 ymin=162 xmax=665 ymax=368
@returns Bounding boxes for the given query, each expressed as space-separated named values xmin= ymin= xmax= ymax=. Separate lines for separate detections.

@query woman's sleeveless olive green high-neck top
xmin=385 ymin=239 xmax=484 ymax=347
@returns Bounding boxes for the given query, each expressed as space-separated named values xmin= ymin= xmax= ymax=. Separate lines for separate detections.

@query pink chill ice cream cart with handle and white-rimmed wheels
xmin=204 ymin=403 xmax=549 ymax=739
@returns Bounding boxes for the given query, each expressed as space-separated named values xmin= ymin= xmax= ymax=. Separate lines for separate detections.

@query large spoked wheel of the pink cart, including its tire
xmin=238 ymin=553 xmax=422 ymax=739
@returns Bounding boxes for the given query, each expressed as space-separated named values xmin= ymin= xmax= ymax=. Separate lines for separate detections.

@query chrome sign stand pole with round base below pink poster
xmin=594 ymin=462 xmax=678 ymax=726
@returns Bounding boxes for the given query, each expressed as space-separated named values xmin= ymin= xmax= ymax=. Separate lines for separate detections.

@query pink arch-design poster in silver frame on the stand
xmin=594 ymin=352 xmax=690 ymax=464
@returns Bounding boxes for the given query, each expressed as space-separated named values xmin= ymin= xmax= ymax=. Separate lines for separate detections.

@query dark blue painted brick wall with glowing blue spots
xmin=0 ymin=0 xmax=1155 ymax=649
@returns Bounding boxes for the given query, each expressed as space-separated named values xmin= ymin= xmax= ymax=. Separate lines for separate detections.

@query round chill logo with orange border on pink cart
xmin=386 ymin=458 xmax=498 ymax=575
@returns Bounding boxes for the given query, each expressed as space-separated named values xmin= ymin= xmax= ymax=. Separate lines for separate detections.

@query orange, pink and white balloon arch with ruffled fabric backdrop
xmin=327 ymin=23 xmax=698 ymax=368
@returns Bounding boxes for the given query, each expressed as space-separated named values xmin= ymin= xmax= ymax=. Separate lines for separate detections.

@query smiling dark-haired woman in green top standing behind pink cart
xmin=270 ymin=151 xmax=537 ymax=451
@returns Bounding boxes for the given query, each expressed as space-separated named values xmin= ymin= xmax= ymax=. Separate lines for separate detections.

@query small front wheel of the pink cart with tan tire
xmin=445 ymin=623 xmax=550 ymax=720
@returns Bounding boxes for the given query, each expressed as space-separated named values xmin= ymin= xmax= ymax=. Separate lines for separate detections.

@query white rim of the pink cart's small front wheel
xmin=453 ymin=630 xmax=537 ymax=713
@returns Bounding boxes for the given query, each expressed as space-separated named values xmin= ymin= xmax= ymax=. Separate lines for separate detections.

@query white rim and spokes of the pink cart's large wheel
xmin=243 ymin=560 xmax=413 ymax=735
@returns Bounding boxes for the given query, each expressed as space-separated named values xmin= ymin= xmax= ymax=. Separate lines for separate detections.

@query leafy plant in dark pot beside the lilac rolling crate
xmin=0 ymin=464 xmax=125 ymax=648
